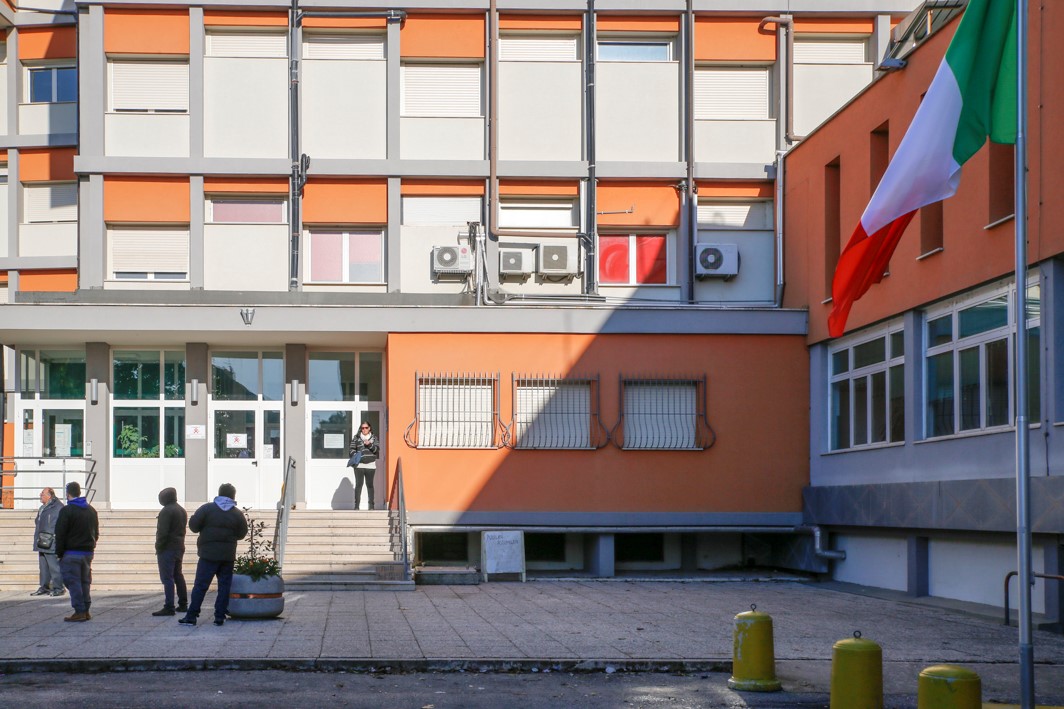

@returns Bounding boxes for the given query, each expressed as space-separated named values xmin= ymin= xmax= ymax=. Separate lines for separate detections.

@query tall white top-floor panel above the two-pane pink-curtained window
xmin=301 ymin=60 xmax=387 ymax=160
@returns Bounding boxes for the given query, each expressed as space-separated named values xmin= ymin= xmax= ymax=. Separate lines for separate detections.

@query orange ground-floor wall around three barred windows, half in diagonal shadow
xmin=387 ymin=333 xmax=809 ymax=512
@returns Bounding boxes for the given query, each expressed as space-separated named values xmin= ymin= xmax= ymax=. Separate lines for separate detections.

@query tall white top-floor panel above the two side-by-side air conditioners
xmin=499 ymin=62 xmax=583 ymax=160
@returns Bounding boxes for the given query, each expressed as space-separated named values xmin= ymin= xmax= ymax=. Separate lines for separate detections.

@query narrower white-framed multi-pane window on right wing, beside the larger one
xmin=829 ymin=323 xmax=905 ymax=450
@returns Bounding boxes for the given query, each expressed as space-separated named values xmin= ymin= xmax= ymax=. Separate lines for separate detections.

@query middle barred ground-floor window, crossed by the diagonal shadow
xmin=509 ymin=375 xmax=605 ymax=449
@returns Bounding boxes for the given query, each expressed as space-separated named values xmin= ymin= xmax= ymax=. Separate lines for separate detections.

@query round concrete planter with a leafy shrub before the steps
xmin=229 ymin=507 xmax=284 ymax=617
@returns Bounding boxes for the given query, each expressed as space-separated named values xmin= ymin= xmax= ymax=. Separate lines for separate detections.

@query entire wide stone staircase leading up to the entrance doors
xmin=0 ymin=510 xmax=414 ymax=594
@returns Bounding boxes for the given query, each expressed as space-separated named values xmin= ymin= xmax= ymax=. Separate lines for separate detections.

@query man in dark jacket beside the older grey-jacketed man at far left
xmin=55 ymin=482 xmax=100 ymax=623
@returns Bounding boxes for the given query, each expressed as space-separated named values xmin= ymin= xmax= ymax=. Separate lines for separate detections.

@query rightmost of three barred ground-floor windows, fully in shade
xmin=613 ymin=377 xmax=715 ymax=450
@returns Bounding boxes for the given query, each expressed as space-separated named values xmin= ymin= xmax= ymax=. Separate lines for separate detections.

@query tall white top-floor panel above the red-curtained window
xmin=595 ymin=62 xmax=680 ymax=162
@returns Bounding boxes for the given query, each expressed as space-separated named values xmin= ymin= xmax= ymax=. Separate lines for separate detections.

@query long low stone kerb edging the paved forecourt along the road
xmin=0 ymin=658 xmax=732 ymax=675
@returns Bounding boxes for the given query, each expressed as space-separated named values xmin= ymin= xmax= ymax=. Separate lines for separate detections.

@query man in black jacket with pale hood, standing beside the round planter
xmin=178 ymin=482 xmax=248 ymax=625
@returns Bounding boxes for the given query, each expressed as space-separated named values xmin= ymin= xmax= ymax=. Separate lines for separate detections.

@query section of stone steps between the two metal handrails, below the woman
xmin=282 ymin=510 xmax=414 ymax=591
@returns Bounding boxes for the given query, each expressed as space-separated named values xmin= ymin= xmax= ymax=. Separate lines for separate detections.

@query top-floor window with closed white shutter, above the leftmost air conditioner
xmin=399 ymin=64 xmax=483 ymax=118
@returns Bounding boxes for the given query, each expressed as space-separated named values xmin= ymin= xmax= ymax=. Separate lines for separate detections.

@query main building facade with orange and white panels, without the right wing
xmin=0 ymin=0 xmax=915 ymax=574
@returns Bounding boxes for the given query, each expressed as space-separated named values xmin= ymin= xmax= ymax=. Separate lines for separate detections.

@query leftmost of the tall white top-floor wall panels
xmin=203 ymin=57 xmax=288 ymax=158
